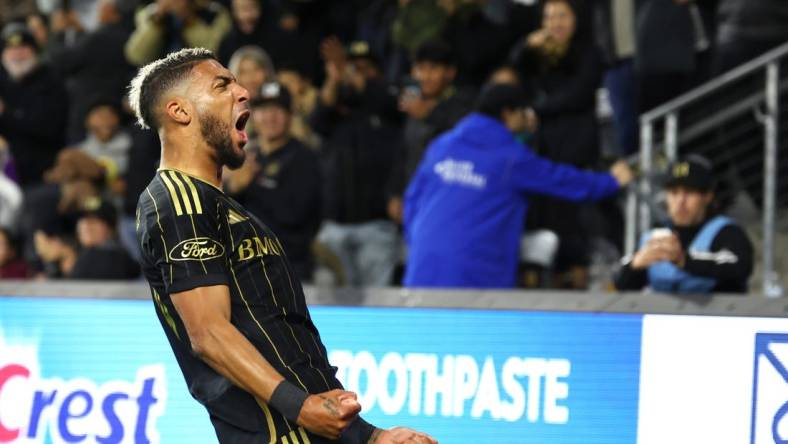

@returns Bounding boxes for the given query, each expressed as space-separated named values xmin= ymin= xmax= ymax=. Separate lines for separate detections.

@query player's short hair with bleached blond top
xmin=129 ymin=48 xmax=216 ymax=129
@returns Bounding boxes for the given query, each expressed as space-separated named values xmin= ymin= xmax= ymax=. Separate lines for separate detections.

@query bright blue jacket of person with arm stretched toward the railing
xmin=404 ymin=113 xmax=619 ymax=288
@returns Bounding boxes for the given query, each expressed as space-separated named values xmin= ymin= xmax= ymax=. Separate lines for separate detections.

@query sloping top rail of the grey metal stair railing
xmin=640 ymin=42 xmax=788 ymax=123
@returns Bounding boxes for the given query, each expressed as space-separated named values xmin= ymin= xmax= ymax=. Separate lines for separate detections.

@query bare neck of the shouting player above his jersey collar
xmin=159 ymin=133 xmax=222 ymax=188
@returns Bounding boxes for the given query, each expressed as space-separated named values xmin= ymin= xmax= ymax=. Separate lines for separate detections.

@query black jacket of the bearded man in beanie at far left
xmin=0 ymin=64 xmax=68 ymax=186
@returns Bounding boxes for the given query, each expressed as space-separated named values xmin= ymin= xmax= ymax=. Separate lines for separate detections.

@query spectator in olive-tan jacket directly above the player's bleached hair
xmin=125 ymin=0 xmax=232 ymax=66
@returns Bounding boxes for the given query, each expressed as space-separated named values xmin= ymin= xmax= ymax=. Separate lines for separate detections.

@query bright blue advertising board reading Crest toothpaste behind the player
xmin=0 ymin=297 xmax=643 ymax=444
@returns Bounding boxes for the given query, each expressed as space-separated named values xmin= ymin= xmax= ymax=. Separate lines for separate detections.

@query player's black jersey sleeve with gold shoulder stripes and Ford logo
xmin=140 ymin=171 xmax=229 ymax=294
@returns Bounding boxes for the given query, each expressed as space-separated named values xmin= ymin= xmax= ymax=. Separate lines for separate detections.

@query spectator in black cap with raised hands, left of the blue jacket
xmin=387 ymin=41 xmax=474 ymax=222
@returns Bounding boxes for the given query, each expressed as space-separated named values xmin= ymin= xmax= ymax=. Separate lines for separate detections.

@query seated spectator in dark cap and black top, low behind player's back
xmin=67 ymin=198 xmax=140 ymax=279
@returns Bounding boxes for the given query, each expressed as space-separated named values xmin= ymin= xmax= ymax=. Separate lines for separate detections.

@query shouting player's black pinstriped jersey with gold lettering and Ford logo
xmin=137 ymin=169 xmax=341 ymax=443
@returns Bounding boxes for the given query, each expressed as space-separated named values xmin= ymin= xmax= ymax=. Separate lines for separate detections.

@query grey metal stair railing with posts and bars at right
xmin=625 ymin=43 xmax=788 ymax=297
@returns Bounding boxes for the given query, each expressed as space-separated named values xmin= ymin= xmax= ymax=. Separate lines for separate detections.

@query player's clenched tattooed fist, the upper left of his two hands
xmin=298 ymin=389 xmax=361 ymax=439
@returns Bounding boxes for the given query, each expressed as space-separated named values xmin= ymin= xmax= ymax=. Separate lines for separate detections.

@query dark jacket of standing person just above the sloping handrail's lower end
xmin=635 ymin=0 xmax=713 ymax=113
